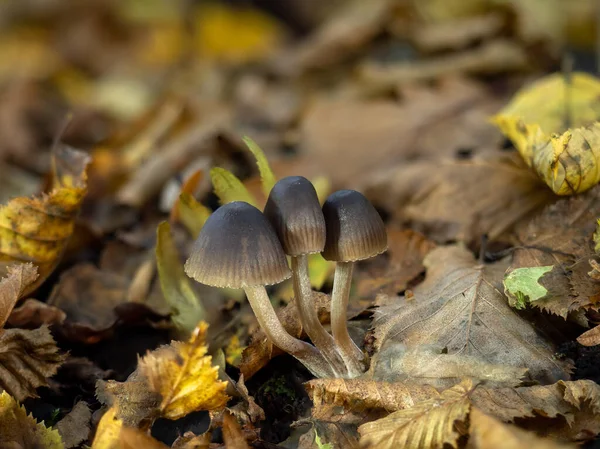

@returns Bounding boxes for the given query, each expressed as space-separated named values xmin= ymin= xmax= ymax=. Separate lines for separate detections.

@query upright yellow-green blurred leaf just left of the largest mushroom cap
xmin=156 ymin=221 xmax=206 ymax=332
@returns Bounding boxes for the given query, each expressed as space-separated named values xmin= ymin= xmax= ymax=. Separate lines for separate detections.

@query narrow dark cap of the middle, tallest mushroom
xmin=264 ymin=176 xmax=325 ymax=256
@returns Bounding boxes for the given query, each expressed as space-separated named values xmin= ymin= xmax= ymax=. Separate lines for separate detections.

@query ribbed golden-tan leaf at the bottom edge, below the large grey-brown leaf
xmin=358 ymin=381 xmax=473 ymax=449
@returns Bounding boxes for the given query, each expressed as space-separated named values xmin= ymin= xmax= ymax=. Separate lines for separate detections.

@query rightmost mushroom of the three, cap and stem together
xmin=323 ymin=190 xmax=387 ymax=376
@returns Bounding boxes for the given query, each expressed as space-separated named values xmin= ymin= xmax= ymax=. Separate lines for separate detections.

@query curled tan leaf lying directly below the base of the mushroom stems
xmin=304 ymin=379 xmax=439 ymax=424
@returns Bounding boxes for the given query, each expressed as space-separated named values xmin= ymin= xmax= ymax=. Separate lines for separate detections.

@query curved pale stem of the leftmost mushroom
xmin=244 ymin=285 xmax=335 ymax=377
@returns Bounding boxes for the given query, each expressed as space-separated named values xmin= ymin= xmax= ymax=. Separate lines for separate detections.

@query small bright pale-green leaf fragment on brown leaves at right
xmin=504 ymin=265 xmax=553 ymax=309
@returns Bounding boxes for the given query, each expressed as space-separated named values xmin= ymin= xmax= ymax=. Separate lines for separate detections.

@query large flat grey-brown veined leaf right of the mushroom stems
xmin=372 ymin=246 xmax=569 ymax=385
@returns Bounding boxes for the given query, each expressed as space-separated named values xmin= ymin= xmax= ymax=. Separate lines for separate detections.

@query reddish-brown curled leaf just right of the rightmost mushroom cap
xmin=356 ymin=229 xmax=435 ymax=299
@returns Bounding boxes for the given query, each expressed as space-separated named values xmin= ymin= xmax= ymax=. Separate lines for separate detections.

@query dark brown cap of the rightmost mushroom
xmin=323 ymin=190 xmax=387 ymax=262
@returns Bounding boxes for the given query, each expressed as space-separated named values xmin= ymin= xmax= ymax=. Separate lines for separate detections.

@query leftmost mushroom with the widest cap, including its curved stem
xmin=184 ymin=201 xmax=333 ymax=377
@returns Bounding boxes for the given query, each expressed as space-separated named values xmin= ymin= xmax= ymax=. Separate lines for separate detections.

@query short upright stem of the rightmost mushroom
xmin=331 ymin=262 xmax=365 ymax=377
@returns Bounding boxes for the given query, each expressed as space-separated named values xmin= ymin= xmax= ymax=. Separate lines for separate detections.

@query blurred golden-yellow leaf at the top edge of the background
xmin=194 ymin=2 xmax=281 ymax=63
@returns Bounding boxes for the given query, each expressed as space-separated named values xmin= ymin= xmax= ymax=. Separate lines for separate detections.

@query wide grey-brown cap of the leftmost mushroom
xmin=184 ymin=201 xmax=291 ymax=288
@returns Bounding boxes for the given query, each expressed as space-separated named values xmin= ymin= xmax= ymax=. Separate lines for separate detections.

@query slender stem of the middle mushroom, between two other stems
xmin=292 ymin=254 xmax=348 ymax=377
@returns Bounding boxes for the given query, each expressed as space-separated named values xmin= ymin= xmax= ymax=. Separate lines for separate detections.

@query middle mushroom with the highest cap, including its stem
xmin=264 ymin=176 xmax=347 ymax=377
